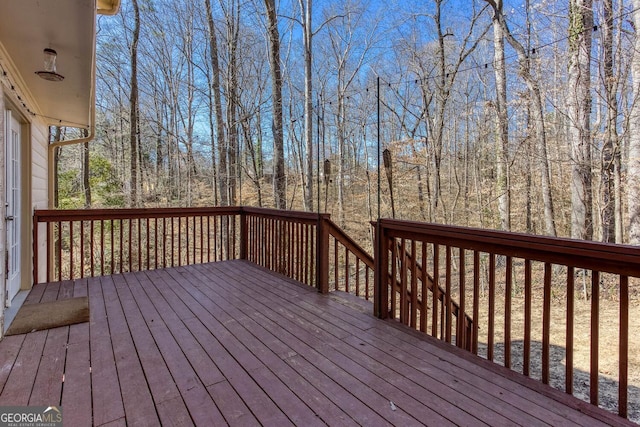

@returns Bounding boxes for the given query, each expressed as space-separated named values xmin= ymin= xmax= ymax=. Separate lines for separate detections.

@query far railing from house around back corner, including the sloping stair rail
xmin=33 ymin=207 xmax=373 ymax=300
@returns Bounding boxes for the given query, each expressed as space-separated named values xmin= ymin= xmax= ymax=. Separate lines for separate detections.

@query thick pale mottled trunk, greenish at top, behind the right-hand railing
xmin=567 ymin=0 xmax=593 ymax=240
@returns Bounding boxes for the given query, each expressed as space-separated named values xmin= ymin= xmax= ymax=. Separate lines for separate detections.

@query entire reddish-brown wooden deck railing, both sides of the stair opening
xmin=33 ymin=207 xmax=640 ymax=417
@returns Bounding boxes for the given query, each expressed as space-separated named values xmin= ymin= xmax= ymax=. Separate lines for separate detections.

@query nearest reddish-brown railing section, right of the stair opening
xmin=375 ymin=219 xmax=640 ymax=417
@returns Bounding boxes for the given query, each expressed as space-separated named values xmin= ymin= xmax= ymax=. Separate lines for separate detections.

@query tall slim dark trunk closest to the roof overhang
xmin=129 ymin=0 xmax=140 ymax=207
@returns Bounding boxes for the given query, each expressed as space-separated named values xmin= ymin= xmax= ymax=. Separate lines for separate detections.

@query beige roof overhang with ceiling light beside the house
xmin=0 ymin=0 xmax=120 ymax=128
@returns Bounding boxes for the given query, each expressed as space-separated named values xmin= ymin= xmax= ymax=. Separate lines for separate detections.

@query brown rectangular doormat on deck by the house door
xmin=5 ymin=297 xmax=89 ymax=335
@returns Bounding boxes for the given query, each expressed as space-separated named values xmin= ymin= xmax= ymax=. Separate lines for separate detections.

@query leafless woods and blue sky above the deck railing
xmin=52 ymin=0 xmax=640 ymax=244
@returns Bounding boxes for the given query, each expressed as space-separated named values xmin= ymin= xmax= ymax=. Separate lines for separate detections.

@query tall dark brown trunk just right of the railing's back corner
xmin=264 ymin=0 xmax=287 ymax=209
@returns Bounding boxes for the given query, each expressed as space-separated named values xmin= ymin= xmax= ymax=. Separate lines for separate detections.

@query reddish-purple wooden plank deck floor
xmin=0 ymin=261 xmax=630 ymax=426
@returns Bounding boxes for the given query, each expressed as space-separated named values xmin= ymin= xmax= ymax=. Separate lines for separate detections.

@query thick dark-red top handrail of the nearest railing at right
xmin=380 ymin=219 xmax=640 ymax=277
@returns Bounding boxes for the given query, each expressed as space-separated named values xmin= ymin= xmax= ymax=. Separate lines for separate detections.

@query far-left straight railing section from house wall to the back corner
xmin=33 ymin=208 xmax=240 ymax=283
